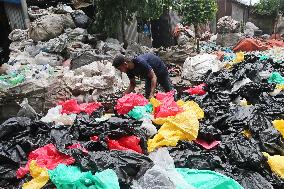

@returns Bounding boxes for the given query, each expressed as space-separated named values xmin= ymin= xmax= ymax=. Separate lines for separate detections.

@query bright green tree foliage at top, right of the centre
xmin=175 ymin=0 xmax=218 ymax=26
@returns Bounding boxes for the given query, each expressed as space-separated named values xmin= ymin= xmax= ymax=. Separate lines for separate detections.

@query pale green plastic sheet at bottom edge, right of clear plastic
xmin=176 ymin=168 xmax=243 ymax=189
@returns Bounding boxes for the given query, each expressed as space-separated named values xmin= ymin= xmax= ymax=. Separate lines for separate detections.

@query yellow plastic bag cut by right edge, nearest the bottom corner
xmin=263 ymin=152 xmax=284 ymax=179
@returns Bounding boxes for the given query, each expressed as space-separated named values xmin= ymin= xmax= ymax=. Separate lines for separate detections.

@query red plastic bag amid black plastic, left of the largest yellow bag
xmin=107 ymin=136 xmax=143 ymax=154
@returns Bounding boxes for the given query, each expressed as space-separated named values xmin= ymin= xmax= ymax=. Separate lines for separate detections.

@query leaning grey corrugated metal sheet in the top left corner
xmin=4 ymin=3 xmax=26 ymax=30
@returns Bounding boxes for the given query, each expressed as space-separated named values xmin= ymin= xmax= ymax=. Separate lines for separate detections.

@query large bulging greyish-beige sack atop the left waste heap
xmin=29 ymin=14 xmax=75 ymax=42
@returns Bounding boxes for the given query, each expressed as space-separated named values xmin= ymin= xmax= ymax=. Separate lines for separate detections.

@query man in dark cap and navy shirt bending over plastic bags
xmin=112 ymin=53 xmax=172 ymax=99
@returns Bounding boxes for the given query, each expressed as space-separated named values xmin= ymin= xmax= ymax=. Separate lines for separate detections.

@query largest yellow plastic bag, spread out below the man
xmin=148 ymin=110 xmax=199 ymax=152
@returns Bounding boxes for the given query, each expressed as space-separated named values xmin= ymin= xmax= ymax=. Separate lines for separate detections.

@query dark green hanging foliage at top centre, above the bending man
xmin=94 ymin=0 xmax=173 ymax=36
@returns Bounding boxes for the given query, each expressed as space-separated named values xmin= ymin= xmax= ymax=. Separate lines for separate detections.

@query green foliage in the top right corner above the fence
xmin=254 ymin=0 xmax=284 ymax=17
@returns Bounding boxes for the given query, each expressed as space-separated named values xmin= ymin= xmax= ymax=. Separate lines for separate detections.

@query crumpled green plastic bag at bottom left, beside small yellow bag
xmin=48 ymin=164 xmax=119 ymax=189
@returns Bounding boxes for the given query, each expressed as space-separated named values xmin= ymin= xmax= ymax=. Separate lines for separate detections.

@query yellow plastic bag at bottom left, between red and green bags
xmin=23 ymin=160 xmax=49 ymax=189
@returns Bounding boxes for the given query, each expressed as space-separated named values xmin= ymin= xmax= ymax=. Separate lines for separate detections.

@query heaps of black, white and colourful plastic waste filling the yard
xmin=0 ymin=1 xmax=284 ymax=189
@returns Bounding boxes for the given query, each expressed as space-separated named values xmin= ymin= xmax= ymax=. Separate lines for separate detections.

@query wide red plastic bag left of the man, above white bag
xmin=59 ymin=99 xmax=102 ymax=115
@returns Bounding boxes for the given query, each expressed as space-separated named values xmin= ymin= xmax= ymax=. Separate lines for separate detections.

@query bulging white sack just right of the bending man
xmin=182 ymin=54 xmax=222 ymax=81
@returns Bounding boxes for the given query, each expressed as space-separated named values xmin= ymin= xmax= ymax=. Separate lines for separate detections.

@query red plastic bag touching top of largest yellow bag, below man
xmin=154 ymin=92 xmax=184 ymax=118
